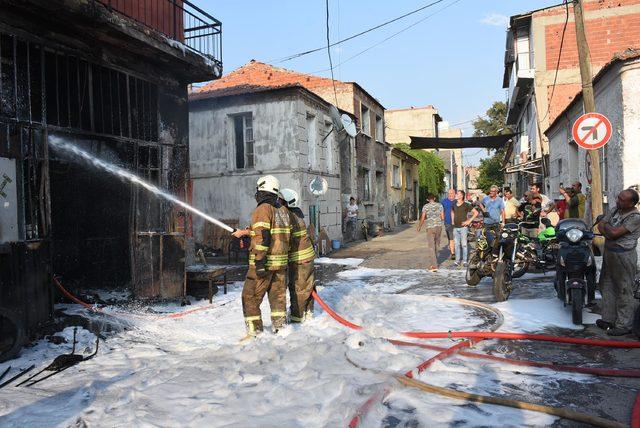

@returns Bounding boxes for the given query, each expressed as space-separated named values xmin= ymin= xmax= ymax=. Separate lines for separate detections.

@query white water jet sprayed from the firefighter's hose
xmin=48 ymin=136 xmax=235 ymax=233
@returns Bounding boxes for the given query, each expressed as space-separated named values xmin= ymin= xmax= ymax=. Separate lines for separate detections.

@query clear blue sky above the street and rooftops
xmin=196 ymin=0 xmax=560 ymax=165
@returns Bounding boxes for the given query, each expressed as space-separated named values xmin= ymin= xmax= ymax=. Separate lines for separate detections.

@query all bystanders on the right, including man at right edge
xmin=417 ymin=182 xmax=640 ymax=336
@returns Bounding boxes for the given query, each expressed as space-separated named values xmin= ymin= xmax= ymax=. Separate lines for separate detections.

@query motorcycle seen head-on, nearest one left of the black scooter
xmin=493 ymin=223 xmax=520 ymax=302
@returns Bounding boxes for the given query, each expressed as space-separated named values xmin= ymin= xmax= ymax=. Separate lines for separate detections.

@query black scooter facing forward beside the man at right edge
xmin=554 ymin=218 xmax=596 ymax=324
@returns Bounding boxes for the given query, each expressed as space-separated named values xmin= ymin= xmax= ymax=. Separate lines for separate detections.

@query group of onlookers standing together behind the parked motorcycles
xmin=418 ymin=182 xmax=586 ymax=271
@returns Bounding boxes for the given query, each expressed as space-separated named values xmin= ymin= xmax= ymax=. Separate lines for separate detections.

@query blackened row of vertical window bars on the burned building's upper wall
xmin=0 ymin=34 xmax=159 ymax=142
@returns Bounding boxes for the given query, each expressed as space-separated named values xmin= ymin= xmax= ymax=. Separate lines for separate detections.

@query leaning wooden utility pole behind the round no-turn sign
xmin=573 ymin=0 xmax=603 ymax=219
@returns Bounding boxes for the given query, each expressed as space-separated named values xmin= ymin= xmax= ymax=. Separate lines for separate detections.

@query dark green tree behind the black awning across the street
xmin=473 ymin=101 xmax=511 ymax=193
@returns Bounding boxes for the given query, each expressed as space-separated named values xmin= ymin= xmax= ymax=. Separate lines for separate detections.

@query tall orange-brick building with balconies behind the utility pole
xmin=503 ymin=0 xmax=640 ymax=194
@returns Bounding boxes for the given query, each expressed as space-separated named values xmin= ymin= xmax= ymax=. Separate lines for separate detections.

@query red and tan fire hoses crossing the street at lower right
xmin=312 ymin=290 xmax=640 ymax=428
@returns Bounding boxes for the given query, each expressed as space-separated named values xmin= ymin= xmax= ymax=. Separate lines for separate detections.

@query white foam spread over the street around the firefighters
xmin=0 ymin=268 xmax=608 ymax=427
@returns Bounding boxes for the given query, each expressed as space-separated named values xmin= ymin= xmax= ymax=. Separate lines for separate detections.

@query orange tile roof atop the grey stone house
xmin=193 ymin=60 xmax=347 ymax=98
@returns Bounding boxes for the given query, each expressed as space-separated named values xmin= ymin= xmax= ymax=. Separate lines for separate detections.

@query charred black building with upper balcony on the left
xmin=0 ymin=0 xmax=222 ymax=338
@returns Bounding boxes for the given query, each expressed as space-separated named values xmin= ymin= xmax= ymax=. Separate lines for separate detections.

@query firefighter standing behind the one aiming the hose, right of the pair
xmin=280 ymin=189 xmax=316 ymax=323
